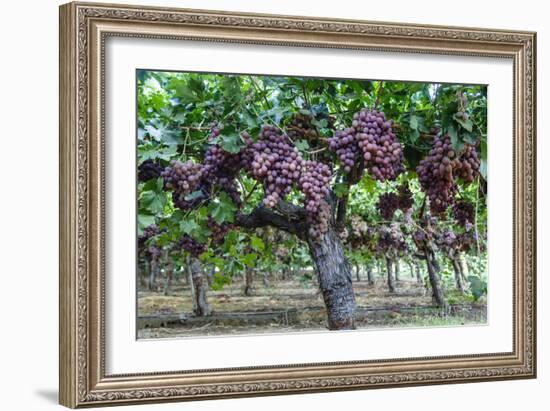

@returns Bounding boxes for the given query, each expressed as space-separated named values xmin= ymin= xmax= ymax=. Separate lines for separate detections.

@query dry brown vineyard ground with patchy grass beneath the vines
xmin=138 ymin=278 xmax=487 ymax=338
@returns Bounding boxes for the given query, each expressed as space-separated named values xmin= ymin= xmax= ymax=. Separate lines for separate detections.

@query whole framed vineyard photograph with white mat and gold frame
xmin=60 ymin=3 xmax=536 ymax=408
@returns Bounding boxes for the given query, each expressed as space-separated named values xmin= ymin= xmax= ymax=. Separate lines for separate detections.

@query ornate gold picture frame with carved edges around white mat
xmin=59 ymin=3 xmax=536 ymax=407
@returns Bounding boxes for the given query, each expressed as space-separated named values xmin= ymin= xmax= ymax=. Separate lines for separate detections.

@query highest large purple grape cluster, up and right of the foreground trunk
xmin=329 ymin=109 xmax=404 ymax=181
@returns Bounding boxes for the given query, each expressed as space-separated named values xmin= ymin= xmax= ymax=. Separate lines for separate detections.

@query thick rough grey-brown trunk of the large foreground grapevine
xmin=308 ymin=226 xmax=355 ymax=330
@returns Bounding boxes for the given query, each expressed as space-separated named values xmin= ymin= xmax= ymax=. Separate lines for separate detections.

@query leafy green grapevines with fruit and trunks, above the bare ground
xmin=137 ymin=71 xmax=487 ymax=329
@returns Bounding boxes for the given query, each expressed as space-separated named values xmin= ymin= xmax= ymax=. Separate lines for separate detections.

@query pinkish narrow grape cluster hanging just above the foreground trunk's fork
xmin=298 ymin=160 xmax=332 ymax=213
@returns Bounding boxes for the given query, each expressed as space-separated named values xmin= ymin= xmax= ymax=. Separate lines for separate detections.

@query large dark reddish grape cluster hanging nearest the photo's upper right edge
xmin=416 ymin=135 xmax=479 ymax=214
